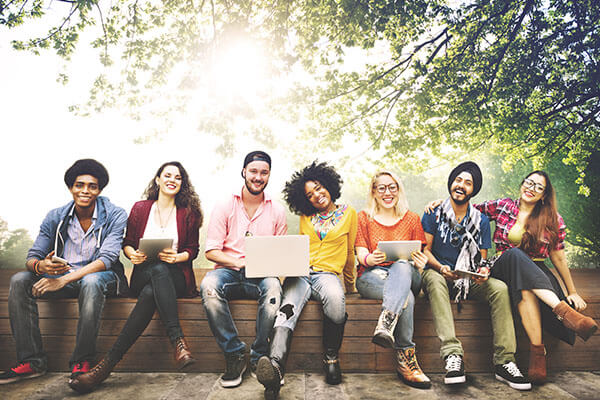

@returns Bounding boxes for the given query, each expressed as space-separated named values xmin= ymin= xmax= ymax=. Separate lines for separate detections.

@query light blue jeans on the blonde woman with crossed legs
xmin=356 ymin=261 xmax=421 ymax=349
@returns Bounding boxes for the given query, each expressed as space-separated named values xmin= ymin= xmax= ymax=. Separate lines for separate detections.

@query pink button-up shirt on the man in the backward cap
xmin=205 ymin=191 xmax=287 ymax=269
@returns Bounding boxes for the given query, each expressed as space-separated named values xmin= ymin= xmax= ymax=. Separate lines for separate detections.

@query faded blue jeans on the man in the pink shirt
xmin=200 ymin=268 xmax=281 ymax=362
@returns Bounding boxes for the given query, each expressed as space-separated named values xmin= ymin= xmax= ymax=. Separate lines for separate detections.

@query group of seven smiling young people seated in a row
xmin=0 ymin=151 xmax=597 ymax=399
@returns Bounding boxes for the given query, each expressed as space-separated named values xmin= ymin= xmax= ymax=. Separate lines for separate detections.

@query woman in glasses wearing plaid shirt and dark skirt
xmin=475 ymin=171 xmax=598 ymax=384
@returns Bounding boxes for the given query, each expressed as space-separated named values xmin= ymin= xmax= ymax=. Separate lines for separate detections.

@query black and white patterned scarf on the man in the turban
xmin=436 ymin=198 xmax=481 ymax=303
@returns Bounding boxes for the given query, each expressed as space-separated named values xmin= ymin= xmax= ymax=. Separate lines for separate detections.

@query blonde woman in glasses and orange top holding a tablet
xmin=355 ymin=171 xmax=431 ymax=389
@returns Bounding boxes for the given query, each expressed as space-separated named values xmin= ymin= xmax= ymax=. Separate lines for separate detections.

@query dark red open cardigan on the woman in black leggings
xmin=123 ymin=200 xmax=200 ymax=297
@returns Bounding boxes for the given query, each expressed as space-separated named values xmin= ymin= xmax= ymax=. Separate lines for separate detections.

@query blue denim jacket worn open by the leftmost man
xmin=27 ymin=196 xmax=128 ymax=295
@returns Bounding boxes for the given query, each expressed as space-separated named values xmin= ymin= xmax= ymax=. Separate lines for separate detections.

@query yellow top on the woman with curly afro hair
xmin=300 ymin=206 xmax=357 ymax=290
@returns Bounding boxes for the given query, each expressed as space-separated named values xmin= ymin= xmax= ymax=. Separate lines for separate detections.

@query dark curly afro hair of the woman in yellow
xmin=283 ymin=161 xmax=344 ymax=216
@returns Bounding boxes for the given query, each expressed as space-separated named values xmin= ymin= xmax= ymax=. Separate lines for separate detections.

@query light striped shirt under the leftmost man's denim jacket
xmin=63 ymin=207 xmax=98 ymax=269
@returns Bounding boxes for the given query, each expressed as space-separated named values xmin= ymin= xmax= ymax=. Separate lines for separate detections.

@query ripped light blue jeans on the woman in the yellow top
xmin=275 ymin=272 xmax=346 ymax=331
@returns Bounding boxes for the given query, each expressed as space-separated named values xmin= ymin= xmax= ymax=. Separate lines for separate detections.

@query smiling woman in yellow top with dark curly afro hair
xmin=257 ymin=161 xmax=356 ymax=399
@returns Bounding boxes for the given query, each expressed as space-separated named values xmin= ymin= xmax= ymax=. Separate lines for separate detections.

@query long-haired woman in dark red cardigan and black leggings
xmin=69 ymin=161 xmax=202 ymax=392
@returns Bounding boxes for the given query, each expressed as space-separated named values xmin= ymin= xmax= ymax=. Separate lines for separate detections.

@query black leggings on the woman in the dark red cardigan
xmin=108 ymin=262 xmax=185 ymax=361
